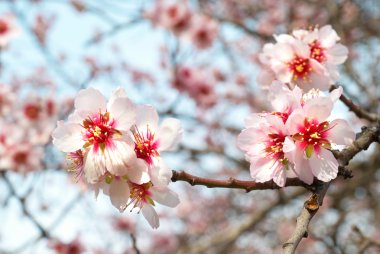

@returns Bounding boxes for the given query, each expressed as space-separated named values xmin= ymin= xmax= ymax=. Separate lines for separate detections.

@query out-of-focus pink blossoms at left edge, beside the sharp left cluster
xmin=0 ymin=84 xmax=67 ymax=174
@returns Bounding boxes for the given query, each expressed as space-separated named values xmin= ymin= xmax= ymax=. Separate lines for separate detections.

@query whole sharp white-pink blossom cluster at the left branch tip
xmin=52 ymin=88 xmax=182 ymax=228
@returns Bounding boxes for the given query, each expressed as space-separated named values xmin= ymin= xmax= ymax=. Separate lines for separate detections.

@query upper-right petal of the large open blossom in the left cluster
xmin=108 ymin=97 xmax=136 ymax=131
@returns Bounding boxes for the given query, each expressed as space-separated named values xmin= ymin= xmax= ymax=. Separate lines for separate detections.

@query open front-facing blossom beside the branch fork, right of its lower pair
xmin=284 ymin=92 xmax=355 ymax=184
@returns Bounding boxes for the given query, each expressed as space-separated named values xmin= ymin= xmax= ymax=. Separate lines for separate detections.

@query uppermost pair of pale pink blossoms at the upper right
xmin=257 ymin=25 xmax=348 ymax=91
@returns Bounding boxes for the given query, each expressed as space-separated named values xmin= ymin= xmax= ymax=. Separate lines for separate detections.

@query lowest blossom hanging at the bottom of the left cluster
xmin=126 ymin=182 xmax=179 ymax=228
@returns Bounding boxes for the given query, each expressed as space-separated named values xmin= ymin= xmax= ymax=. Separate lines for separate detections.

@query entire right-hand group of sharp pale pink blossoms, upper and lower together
xmin=237 ymin=26 xmax=355 ymax=187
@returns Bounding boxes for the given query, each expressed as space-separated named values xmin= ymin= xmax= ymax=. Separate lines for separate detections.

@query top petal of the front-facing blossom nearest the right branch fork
xmin=303 ymin=97 xmax=333 ymax=122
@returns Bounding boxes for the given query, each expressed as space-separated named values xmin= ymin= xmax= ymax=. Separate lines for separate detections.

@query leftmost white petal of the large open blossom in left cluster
xmin=52 ymin=121 xmax=85 ymax=153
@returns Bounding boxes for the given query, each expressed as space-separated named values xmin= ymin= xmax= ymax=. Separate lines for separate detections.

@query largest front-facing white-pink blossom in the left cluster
xmin=52 ymin=88 xmax=150 ymax=184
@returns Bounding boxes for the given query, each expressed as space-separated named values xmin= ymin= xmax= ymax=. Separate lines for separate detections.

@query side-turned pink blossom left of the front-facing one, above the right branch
xmin=237 ymin=114 xmax=293 ymax=187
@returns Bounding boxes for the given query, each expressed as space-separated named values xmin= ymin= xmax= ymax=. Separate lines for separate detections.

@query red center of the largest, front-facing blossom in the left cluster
xmin=83 ymin=112 xmax=120 ymax=152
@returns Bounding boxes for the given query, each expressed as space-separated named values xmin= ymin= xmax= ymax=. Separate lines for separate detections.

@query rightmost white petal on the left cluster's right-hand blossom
xmin=157 ymin=118 xmax=183 ymax=151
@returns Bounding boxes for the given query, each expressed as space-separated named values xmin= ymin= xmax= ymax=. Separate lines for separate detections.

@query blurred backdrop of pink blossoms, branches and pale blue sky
xmin=0 ymin=0 xmax=380 ymax=254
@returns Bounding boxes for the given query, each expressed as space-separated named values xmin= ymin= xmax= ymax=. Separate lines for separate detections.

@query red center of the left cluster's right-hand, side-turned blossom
xmin=133 ymin=126 xmax=160 ymax=165
